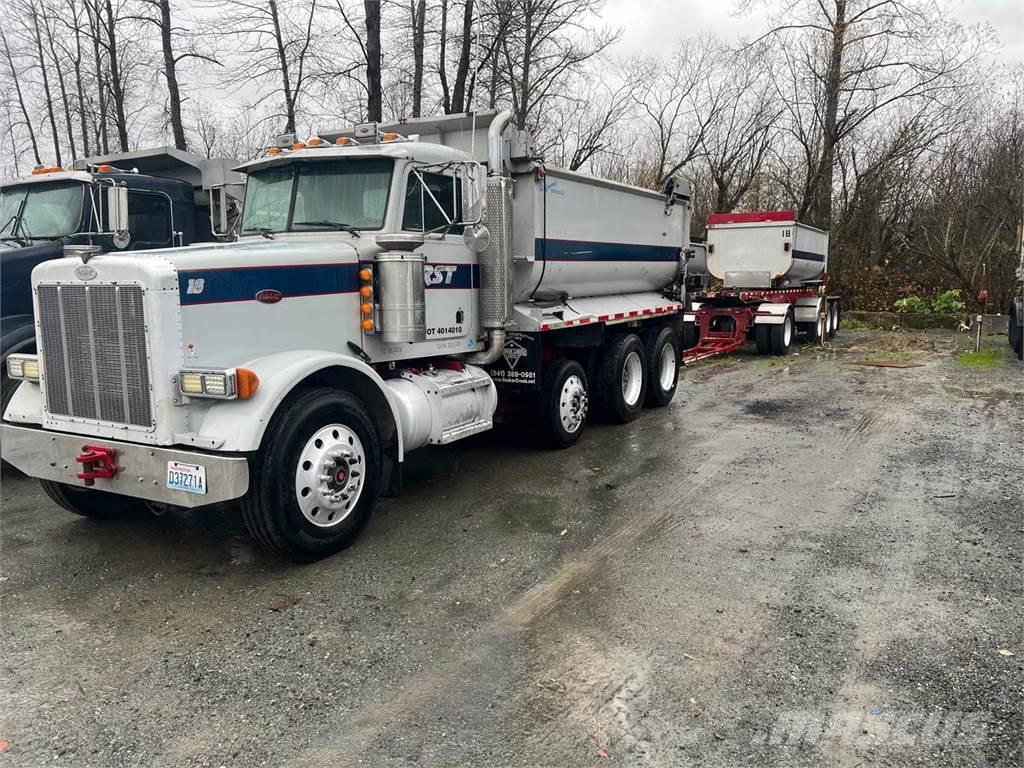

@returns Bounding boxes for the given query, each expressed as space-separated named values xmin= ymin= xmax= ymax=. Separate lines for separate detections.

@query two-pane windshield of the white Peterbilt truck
xmin=242 ymin=158 xmax=393 ymax=234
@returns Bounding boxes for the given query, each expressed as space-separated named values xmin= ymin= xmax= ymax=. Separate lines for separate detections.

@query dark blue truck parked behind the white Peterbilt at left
xmin=0 ymin=146 xmax=244 ymax=413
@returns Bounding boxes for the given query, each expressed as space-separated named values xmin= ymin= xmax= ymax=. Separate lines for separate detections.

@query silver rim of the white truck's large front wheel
xmin=295 ymin=424 xmax=367 ymax=528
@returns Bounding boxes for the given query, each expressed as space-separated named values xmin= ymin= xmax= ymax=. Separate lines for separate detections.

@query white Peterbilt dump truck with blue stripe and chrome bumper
xmin=2 ymin=112 xmax=690 ymax=560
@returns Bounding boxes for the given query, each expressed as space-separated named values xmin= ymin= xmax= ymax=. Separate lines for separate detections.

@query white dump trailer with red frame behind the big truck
xmin=683 ymin=211 xmax=840 ymax=362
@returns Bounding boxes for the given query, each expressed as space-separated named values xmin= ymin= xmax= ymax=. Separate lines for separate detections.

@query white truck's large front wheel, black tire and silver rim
xmin=242 ymin=387 xmax=382 ymax=562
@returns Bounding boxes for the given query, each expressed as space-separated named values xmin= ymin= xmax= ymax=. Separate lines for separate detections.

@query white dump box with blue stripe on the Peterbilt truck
xmin=512 ymin=168 xmax=690 ymax=303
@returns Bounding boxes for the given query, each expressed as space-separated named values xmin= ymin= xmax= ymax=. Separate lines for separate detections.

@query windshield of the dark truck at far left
xmin=0 ymin=181 xmax=85 ymax=240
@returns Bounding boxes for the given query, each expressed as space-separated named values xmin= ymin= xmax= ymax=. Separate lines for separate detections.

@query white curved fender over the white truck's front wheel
xmin=184 ymin=349 xmax=404 ymax=462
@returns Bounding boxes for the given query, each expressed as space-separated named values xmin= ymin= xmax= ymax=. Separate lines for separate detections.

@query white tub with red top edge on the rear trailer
xmin=708 ymin=211 xmax=828 ymax=288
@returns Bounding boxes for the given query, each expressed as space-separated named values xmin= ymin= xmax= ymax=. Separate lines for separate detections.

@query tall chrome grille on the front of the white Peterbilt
xmin=36 ymin=286 xmax=153 ymax=427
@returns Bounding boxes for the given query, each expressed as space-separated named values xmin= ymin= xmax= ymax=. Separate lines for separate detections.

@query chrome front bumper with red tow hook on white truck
xmin=0 ymin=424 xmax=249 ymax=507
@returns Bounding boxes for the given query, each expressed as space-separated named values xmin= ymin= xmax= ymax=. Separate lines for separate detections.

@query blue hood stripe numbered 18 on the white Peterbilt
xmin=178 ymin=262 xmax=359 ymax=305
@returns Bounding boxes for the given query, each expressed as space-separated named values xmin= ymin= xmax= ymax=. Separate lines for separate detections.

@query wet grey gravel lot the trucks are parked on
xmin=0 ymin=333 xmax=1024 ymax=768
